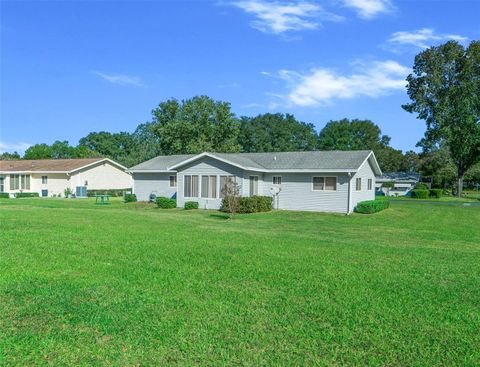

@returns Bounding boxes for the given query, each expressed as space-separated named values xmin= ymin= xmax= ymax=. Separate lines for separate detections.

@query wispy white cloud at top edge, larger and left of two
xmin=232 ymin=0 xmax=343 ymax=34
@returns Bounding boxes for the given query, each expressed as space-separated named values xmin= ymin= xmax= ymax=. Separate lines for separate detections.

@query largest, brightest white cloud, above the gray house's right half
xmin=268 ymin=60 xmax=410 ymax=107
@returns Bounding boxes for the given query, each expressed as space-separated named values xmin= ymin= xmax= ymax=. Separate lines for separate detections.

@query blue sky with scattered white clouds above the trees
xmin=0 ymin=0 xmax=480 ymax=151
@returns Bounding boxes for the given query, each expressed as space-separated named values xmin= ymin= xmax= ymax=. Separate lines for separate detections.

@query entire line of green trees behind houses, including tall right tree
xmin=0 ymin=41 xmax=480 ymax=193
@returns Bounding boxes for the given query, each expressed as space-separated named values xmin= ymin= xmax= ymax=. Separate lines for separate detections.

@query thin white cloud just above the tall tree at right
xmin=387 ymin=28 xmax=468 ymax=51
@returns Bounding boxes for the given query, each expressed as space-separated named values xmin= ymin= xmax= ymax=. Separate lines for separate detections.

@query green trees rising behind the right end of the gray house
xmin=318 ymin=119 xmax=407 ymax=172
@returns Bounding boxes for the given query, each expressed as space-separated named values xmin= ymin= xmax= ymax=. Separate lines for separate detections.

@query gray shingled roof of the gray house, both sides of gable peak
xmin=130 ymin=150 xmax=371 ymax=171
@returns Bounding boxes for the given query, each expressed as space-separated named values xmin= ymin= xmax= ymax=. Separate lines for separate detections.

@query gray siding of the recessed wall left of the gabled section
xmin=133 ymin=173 xmax=177 ymax=201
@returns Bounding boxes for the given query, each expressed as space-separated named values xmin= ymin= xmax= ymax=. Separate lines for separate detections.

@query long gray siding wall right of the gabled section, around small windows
xmin=263 ymin=173 xmax=349 ymax=213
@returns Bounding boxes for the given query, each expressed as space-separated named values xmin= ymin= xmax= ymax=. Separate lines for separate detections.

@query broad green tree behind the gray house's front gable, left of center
xmin=152 ymin=96 xmax=240 ymax=155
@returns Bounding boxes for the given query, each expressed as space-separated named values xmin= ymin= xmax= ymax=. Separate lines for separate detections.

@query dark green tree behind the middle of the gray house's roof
xmin=238 ymin=113 xmax=317 ymax=152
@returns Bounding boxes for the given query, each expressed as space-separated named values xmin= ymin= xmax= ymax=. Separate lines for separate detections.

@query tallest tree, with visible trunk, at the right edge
xmin=403 ymin=41 xmax=480 ymax=196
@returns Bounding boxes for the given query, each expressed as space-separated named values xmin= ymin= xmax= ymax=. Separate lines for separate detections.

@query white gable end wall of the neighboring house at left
xmin=70 ymin=162 xmax=132 ymax=192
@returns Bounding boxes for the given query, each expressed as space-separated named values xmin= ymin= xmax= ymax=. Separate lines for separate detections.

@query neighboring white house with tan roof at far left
xmin=0 ymin=158 xmax=132 ymax=197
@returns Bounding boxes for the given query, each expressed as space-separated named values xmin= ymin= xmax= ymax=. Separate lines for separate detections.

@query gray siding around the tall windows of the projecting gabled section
xmin=177 ymin=157 xmax=244 ymax=209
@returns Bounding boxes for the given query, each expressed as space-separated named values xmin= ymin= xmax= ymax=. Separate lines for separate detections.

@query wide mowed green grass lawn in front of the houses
xmin=0 ymin=199 xmax=480 ymax=366
